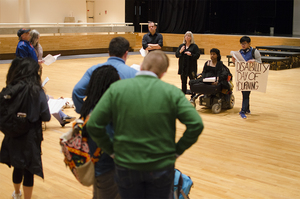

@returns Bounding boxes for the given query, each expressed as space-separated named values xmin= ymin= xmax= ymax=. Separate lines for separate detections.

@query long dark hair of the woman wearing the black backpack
xmin=6 ymin=57 xmax=42 ymax=96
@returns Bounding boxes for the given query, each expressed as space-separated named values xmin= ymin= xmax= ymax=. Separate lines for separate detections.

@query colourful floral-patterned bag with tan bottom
xmin=60 ymin=117 xmax=102 ymax=186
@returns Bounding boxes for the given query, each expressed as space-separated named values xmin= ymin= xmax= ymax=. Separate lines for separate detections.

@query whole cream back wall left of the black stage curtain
xmin=0 ymin=0 xmax=125 ymax=23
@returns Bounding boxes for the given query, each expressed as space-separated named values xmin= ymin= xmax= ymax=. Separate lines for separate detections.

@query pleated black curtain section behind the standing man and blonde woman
xmin=150 ymin=0 xmax=209 ymax=33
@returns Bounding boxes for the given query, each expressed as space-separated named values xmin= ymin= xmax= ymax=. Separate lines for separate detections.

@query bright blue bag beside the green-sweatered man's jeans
xmin=174 ymin=169 xmax=193 ymax=199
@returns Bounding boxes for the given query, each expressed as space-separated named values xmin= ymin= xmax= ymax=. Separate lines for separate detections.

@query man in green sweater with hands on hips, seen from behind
xmin=86 ymin=50 xmax=203 ymax=199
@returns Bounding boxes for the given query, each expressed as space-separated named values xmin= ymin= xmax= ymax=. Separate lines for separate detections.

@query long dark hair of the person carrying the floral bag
xmin=80 ymin=65 xmax=120 ymax=118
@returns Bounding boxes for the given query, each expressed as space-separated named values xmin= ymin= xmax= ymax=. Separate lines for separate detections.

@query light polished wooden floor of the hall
xmin=0 ymin=54 xmax=300 ymax=199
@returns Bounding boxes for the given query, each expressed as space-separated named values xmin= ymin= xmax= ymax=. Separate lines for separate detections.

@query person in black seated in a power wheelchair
xmin=190 ymin=48 xmax=234 ymax=113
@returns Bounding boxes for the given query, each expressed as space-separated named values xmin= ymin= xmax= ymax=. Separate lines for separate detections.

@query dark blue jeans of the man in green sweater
xmin=115 ymin=165 xmax=174 ymax=199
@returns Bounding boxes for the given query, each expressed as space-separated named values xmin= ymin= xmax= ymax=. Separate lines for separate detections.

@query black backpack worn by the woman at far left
xmin=0 ymin=81 xmax=30 ymax=138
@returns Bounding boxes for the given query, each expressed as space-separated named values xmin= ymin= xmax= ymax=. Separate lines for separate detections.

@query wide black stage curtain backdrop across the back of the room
xmin=125 ymin=0 xmax=293 ymax=35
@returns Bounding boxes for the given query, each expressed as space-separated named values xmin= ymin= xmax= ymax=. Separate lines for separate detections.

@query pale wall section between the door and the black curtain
xmin=94 ymin=0 xmax=125 ymax=23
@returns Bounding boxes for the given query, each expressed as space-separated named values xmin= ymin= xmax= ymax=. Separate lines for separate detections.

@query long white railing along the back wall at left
xmin=0 ymin=23 xmax=134 ymax=35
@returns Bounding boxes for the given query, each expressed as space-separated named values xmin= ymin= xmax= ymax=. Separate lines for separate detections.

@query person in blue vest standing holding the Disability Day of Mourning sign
xmin=232 ymin=36 xmax=261 ymax=119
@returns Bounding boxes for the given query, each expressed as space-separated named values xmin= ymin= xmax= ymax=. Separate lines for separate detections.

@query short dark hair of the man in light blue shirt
xmin=108 ymin=37 xmax=129 ymax=58
